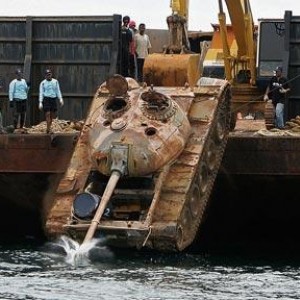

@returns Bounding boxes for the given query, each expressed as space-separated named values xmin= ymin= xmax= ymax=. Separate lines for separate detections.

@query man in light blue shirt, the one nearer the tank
xmin=39 ymin=69 xmax=64 ymax=133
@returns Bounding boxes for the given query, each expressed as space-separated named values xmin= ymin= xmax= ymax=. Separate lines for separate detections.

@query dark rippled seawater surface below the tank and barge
xmin=0 ymin=240 xmax=300 ymax=300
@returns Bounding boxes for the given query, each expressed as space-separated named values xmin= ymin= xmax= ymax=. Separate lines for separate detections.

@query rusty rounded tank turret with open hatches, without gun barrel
xmin=89 ymin=76 xmax=191 ymax=176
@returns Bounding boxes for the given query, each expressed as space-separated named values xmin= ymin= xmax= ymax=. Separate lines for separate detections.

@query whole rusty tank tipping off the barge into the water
xmin=45 ymin=75 xmax=231 ymax=251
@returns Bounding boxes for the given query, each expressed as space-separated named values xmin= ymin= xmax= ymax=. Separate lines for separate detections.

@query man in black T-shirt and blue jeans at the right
xmin=264 ymin=67 xmax=290 ymax=129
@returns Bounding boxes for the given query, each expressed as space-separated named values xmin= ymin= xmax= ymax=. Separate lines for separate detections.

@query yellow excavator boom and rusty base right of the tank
xmin=218 ymin=0 xmax=273 ymax=129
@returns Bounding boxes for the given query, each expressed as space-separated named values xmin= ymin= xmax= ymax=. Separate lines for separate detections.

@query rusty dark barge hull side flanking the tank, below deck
xmin=0 ymin=120 xmax=300 ymax=251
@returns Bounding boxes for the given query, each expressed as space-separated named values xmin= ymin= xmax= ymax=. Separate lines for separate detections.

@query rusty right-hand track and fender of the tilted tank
xmin=148 ymin=80 xmax=231 ymax=251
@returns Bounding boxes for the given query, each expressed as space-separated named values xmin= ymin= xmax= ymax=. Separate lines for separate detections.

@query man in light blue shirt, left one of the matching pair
xmin=8 ymin=69 xmax=29 ymax=129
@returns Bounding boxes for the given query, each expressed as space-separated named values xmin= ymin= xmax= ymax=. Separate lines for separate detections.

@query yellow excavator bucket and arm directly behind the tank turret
xmin=144 ymin=0 xmax=200 ymax=86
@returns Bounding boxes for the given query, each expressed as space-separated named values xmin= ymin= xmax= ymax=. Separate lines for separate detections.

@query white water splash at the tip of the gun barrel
xmin=47 ymin=235 xmax=113 ymax=267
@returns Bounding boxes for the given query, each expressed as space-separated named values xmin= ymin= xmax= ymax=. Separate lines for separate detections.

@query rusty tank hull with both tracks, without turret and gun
xmin=45 ymin=78 xmax=230 ymax=251
